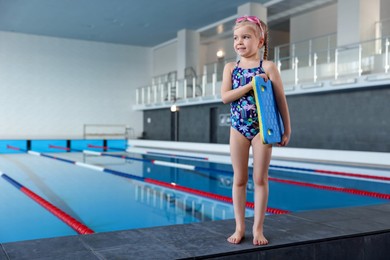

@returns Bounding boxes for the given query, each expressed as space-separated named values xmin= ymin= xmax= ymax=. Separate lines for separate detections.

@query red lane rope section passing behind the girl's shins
xmin=145 ymin=178 xmax=289 ymax=214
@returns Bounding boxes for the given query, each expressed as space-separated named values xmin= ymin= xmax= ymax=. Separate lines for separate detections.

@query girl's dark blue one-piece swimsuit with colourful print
xmin=230 ymin=60 xmax=265 ymax=140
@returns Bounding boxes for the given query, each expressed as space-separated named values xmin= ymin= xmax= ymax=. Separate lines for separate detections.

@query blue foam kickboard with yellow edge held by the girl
xmin=252 ymin=76 xmax=284 ymax=144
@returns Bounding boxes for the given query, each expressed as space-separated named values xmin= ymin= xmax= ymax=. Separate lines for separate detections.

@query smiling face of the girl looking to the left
xmin=233 ymin=25 xmax=264 ymax=58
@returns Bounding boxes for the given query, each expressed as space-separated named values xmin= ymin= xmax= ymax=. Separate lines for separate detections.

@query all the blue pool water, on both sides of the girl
xmin=0 ymin=144 xmax=390 ymax=242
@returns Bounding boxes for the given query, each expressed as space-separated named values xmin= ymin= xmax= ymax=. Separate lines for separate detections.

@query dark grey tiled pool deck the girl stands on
xmin=0 ymin=204 xmax=390 ymax=260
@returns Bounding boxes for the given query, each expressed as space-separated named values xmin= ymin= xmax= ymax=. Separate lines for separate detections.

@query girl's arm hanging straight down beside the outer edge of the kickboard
xmin=263 ymin=61 xmax=291 ymax=146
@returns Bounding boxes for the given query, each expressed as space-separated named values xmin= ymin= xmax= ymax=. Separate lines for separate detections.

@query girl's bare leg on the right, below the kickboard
xmin=252 ymin=135 xmax=272 ymax=245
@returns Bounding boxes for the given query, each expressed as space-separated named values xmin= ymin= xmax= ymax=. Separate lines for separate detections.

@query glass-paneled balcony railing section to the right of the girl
xmin=277 ymin=38 xmax=389 ymax=87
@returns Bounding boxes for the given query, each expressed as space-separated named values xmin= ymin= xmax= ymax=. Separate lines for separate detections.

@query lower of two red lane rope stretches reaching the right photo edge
xmin=269 ymin=177 xmax=390 ymax=200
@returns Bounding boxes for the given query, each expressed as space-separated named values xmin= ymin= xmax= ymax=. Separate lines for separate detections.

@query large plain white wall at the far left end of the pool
xmin=0 ymin=32 xmax=151 ymax=139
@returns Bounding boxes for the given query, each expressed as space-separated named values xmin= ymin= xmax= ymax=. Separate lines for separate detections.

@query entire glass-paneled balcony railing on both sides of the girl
xmin=136 ymin=34 xmax=390 ymax=105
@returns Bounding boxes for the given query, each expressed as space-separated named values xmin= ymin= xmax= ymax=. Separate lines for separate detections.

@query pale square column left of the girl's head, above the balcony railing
xmin=177 ymin=29 xmax=200 ymax=79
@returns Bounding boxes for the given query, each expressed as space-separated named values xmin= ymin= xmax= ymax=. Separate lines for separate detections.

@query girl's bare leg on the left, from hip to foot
xmin=227 ymin=128 xmax=250 ymax=244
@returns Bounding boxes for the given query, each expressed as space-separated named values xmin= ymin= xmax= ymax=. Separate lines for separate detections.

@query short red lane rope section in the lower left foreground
xmin=20 ymin=187 xmax=95 ymax=235
